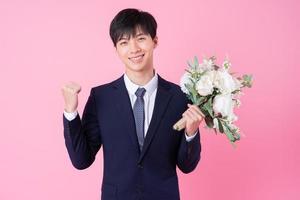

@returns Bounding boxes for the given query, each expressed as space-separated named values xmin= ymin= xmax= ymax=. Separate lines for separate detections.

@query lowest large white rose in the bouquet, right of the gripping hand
xmin=213 ymin=93 xmax=237 ymax=121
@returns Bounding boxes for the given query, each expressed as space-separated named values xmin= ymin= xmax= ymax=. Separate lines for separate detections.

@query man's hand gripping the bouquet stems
xmin=182 ymin=104 xmax=205 ymax=136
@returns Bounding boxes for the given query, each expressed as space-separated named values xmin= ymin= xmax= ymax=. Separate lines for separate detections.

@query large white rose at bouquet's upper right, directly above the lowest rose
xmin=214 ymin=69 xmax=241 ymax=94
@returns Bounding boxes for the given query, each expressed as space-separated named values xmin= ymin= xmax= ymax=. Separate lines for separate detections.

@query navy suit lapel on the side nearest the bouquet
xmin=138 ymin=76 xmax=172 ymax=162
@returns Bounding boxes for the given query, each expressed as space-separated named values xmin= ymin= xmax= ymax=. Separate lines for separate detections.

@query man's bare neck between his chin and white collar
xmin=125 ymin=68 xmax=155 ymax=86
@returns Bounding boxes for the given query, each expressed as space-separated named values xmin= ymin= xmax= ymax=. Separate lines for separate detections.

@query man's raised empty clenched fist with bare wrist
xmin=61 ymin=82 xmax=81 ymax=112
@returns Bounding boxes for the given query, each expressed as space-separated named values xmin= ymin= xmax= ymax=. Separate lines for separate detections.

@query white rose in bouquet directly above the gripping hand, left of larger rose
xmin=196 ymin=71 xmax=214 ymax=96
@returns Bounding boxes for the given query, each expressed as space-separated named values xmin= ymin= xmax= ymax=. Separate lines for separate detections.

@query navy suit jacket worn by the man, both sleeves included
xmin=63 ymin=76 xmax=201 ymax=200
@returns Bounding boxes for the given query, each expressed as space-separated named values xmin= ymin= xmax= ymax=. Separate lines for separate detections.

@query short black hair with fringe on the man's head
xmin=109 ymin=8 xmax=157 ymax=46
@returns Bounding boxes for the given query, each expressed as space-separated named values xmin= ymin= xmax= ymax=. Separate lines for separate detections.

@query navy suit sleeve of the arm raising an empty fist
xmin=63 ymin=89 xmax=101 ymax=169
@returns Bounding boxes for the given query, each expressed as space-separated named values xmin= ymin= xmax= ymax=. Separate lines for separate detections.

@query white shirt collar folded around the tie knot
xmin=124 ymin=71 xmax=158 ymax=95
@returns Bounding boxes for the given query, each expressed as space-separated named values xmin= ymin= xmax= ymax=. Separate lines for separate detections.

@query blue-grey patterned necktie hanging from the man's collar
xmin=133 ymin=88 xmax=146 ymax=151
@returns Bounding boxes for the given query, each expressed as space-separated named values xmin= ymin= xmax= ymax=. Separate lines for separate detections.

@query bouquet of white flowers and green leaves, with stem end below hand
xmin=173 ymin=56 xmax=252 ymax=145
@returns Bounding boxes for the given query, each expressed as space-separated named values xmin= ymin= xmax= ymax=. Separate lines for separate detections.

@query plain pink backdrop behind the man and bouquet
xmin=0 ymin=0 xmax=300 ymax=200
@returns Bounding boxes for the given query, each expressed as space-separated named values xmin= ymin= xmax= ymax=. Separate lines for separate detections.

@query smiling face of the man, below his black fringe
xmin=116 ymin=28 xmax=157 ymax=72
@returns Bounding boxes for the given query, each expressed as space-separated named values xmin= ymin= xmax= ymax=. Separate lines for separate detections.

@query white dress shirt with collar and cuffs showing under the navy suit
xmin=64 ymin=72 xmax=197 ymax=142
